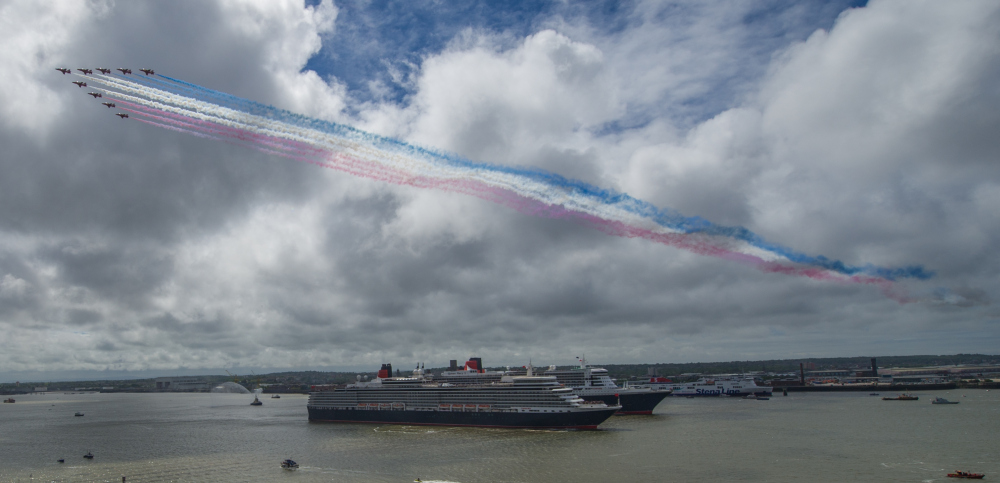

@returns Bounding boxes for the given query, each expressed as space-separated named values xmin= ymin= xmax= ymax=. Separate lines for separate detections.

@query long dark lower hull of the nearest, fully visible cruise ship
xmin=308 ymin=406 xmax=615 ymax=429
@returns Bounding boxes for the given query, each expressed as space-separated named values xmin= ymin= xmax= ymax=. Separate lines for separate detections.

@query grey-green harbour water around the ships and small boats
xmin=0 ymin=390 xmax=1000 ymax=483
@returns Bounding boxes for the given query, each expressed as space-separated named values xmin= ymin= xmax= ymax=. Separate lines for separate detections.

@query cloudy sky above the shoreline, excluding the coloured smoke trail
xmin=0 ymin=0 xmax=1000 ymax=381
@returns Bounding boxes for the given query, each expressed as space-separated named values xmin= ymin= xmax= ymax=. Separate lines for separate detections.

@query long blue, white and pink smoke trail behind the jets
xmin=78 ymin=75 xmax=933 ymax=301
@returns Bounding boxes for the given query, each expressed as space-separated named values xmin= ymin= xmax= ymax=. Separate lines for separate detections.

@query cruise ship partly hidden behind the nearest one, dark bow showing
xmin=435 ymin=357 xmax=670 ymax=415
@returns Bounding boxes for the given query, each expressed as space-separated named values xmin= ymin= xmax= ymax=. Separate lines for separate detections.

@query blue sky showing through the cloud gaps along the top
xmin=305 ymin=0 xmax=867 ymax=125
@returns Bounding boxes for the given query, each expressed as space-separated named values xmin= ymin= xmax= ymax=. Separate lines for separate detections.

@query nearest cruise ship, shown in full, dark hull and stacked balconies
xmin=307 ymin=364 xmax=620 ymax=429
